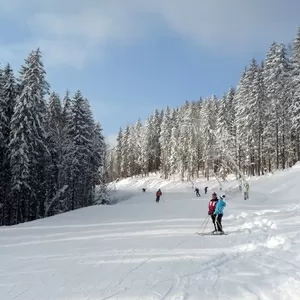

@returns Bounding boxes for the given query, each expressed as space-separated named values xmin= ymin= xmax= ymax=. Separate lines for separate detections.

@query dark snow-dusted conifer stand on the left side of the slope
xmin=0 ymin=49 xmax=106 ymax=225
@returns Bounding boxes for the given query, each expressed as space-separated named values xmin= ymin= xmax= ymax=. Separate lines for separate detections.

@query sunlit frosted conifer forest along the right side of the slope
xmin=107 ymin=29 xmax=300 ymax=180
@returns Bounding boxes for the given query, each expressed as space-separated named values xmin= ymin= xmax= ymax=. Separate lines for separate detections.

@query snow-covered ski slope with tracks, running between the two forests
xmin=0 ymin=165 xmax=300 ymax=300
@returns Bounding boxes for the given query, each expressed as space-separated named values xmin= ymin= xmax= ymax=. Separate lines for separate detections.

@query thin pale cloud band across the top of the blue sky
xmin=0 ymin=0 xmax=300 ymax=67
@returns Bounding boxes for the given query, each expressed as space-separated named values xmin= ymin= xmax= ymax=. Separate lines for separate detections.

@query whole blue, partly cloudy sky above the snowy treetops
xmin=0 ymin=0 xmax=300 ymax=143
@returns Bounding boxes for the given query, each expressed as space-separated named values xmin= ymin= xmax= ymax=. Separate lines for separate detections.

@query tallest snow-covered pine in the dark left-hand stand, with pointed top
xmin=9 ymin=49 xmax=49 ymax=224
